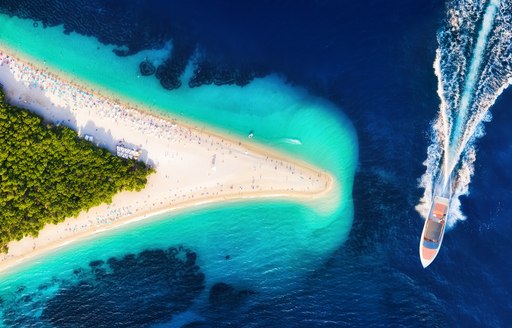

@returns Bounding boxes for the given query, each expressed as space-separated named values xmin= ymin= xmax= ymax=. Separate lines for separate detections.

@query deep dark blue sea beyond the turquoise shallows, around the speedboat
xmin=0 ymin=0 xmax=512 ymax=327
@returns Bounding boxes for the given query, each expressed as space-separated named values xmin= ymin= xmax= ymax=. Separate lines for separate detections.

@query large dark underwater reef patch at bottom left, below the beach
xmin=33 ymin=247 xmax=204 ymax=327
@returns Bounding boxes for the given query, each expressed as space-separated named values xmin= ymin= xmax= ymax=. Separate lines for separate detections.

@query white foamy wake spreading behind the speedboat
xmin=416 ymin=0 xmax=512 ymax=226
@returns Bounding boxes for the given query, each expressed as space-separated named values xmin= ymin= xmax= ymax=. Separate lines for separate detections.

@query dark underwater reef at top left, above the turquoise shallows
xmin=0 ymin=0 xmax=267 ymax=90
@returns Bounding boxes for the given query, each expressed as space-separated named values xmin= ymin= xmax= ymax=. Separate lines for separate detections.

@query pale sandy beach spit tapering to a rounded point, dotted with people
xmin=0 ymin=50 xmax=335 ymax=271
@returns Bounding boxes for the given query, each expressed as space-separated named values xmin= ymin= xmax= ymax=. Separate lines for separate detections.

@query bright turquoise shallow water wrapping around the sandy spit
xmin=0 ymin=15 xmax=358 ymax=318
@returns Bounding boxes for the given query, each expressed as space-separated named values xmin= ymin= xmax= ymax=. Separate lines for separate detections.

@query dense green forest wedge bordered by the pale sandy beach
xmin=0 ymin=88 xmax=154 ymax=252
